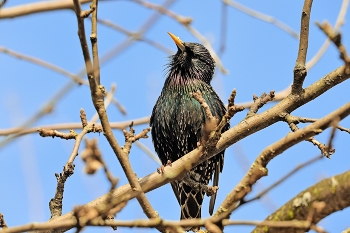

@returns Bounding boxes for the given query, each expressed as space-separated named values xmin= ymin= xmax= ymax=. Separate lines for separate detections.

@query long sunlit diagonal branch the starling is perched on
xmin=40 ymin=66 xmax=350 ymax=231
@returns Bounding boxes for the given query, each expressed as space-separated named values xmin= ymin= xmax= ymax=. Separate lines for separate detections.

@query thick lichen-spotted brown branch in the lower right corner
xmin=254 ymin=171 xmax=350 ymax=233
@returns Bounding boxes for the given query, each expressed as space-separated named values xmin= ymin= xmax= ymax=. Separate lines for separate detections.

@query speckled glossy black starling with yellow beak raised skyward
xmin=150 ymin=32 xmax=230 ymax=232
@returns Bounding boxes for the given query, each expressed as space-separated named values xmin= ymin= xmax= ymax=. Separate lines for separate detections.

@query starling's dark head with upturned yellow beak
xmin=168 ymin=32 xmax=215 ymax=84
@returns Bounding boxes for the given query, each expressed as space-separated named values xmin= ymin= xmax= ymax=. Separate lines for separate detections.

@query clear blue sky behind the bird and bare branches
xmin=0 ymin=0 xmax=350 ymax=232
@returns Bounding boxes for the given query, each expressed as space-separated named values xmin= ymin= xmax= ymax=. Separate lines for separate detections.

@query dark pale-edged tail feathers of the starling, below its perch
xmin=171 ymin=180 xmax=204 ymax=232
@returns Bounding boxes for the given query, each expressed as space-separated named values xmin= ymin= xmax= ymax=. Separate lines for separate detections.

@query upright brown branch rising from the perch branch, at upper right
xmin=292 ymin=0 xmax=312 ymax=94
